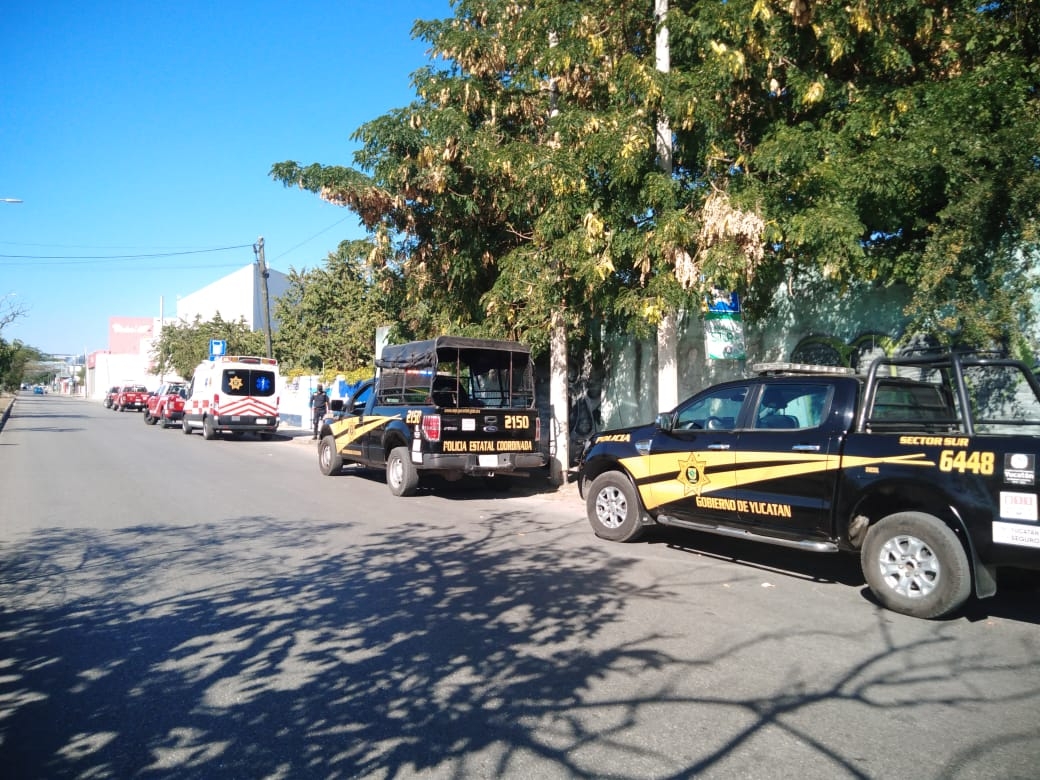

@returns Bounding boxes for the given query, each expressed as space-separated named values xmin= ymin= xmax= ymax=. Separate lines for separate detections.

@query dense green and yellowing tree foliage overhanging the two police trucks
xmin=271 ymin=0 xmax=1040 ymax=348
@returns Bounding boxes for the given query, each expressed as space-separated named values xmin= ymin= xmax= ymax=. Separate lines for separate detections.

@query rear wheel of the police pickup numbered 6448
xmin=860 ymin=512 xmax=971 ymax=619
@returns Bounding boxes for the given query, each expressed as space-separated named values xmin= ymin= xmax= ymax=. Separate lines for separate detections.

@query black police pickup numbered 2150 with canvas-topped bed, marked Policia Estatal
xmin=318 ymin=336 xmax=548 ymax=496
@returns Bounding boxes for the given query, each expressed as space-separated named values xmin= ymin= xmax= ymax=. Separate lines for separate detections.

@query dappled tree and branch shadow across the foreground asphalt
xmin=0 ymin=513 xmax=1040 ymax=780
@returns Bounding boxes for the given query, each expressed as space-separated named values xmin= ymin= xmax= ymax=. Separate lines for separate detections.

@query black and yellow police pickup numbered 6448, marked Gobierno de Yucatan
xmin=579 ymin=352 xmax=1040 ymax=618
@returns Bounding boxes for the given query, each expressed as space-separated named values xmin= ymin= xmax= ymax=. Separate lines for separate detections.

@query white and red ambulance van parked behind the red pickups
xmin=181 ymin=355 xmax=280 ymax=439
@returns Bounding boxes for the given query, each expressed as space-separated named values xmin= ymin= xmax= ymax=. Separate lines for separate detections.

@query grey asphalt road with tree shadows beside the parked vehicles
xmin=0 ymin=394 xmax=1040 ymax=779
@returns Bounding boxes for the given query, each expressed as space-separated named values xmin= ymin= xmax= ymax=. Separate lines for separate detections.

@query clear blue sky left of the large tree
xmin=0 ymin=0 xmax=452 ymax=354
